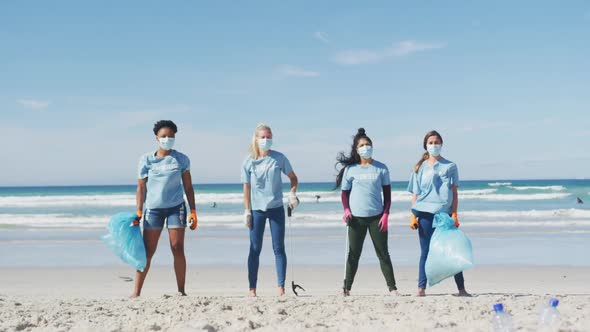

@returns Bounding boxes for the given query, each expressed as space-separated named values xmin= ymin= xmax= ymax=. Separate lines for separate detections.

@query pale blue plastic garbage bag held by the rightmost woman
xmin=425 ymin=213 xmax=473 ymax=286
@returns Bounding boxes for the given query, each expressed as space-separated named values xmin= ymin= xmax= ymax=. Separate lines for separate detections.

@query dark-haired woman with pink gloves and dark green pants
xmin=336 ymin=128 xmax=399 ymax=296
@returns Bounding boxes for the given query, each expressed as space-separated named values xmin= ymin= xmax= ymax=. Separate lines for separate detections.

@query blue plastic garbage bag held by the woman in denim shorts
xmin=101 ymin=213 xmax=147 ymax=271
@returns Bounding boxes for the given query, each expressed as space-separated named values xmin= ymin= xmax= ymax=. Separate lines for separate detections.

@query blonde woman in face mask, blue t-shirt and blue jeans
xmin=242 ymin=124 xmax=299 ymax=296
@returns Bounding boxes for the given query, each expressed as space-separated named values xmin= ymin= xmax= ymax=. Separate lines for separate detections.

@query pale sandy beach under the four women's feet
xmin=0 ymin=265 xmax=590 ymax=331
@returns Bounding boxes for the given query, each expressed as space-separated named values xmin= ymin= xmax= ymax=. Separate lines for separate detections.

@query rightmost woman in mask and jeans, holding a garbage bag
xmin=408 ymin=130 xmax=469 ymax=296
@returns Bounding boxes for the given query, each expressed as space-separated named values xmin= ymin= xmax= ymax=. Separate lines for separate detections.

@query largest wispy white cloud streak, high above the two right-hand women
xmin=334 ymin=40 xmax=446 ymax=66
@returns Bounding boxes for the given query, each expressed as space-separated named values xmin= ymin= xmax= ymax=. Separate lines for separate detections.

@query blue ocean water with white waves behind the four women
xmin=0 ymin=180 xmax=590 ymax=267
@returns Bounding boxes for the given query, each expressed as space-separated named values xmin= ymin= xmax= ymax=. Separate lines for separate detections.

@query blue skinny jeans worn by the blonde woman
xmin=248 ymin=206 xmax=287 ymax=288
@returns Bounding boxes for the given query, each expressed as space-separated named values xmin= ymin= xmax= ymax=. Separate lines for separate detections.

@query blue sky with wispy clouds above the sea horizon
xmin=0 ymin=1 xmax=590 ymax=186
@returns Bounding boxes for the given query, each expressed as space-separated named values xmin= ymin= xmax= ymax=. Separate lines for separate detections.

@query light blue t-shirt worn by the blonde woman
xmin=242 ymin=150 xmax=293 ymax=211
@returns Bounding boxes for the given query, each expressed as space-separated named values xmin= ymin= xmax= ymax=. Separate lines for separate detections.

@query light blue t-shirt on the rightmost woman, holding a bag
xmin=408 ymin=157 xmax=459 ymax=214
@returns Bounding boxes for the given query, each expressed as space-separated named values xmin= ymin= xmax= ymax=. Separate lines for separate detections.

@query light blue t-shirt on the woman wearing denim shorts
xmin=138 ymin=150 xmax=190 ymax=209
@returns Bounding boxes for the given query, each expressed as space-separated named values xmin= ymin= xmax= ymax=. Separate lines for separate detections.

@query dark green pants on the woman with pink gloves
xmin=344 ymin=215 xmax=397 ymax=291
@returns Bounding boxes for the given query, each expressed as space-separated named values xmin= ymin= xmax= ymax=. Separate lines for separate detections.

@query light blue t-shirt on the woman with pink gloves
xmin=341 ymin=160 xmax=391 ymax=217
